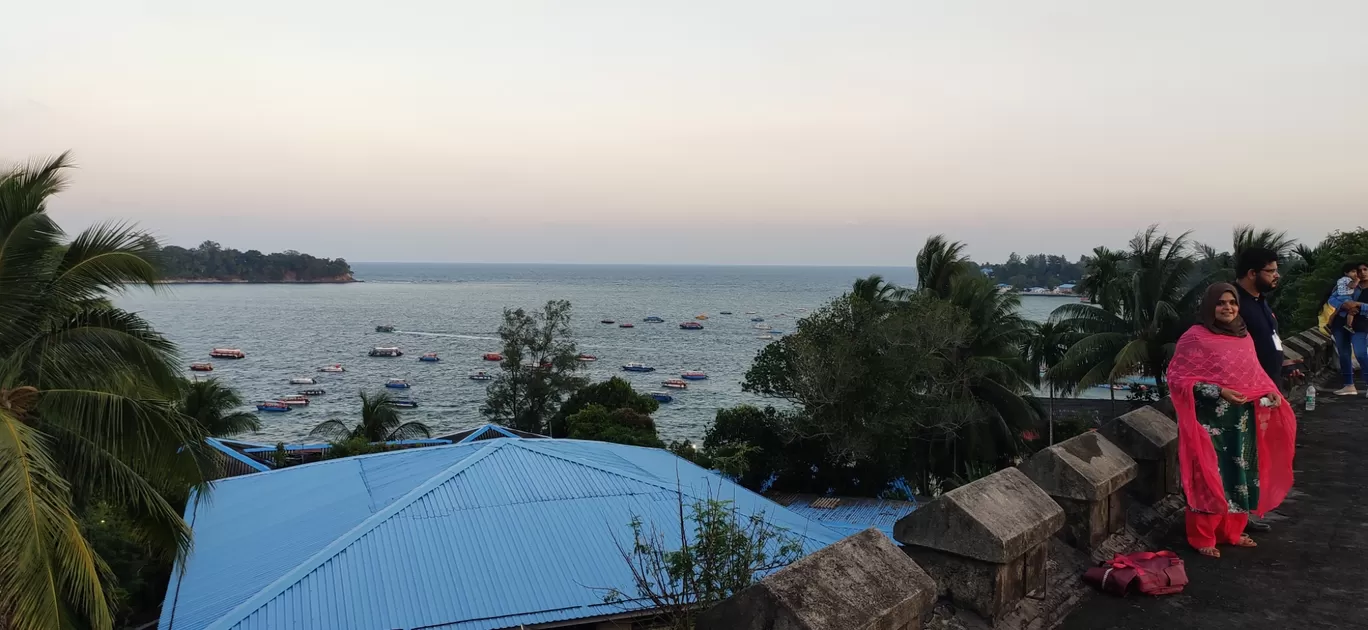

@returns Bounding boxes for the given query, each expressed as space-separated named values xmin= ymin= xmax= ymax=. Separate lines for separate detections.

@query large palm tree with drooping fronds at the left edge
xmin=0 ymin=153 xmax=205 ymax=630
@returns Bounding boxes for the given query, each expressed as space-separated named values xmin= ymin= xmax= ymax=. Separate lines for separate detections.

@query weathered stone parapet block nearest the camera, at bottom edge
xmin=696 ymin=529 xmax=936 ymax=630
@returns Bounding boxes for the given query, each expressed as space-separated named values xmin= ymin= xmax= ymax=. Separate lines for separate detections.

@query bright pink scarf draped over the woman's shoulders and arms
xmin=1168 ymin=325 xmax=1297 ymax=515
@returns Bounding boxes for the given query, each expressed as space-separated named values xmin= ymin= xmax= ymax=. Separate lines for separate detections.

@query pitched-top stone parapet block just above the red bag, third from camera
xmin=1021 ymin=432 xmax=1137 ymax=549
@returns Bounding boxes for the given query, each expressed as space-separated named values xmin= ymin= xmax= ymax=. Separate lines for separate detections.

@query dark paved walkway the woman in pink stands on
xmin=1060 ymin=396 xmax=1368 ymax=630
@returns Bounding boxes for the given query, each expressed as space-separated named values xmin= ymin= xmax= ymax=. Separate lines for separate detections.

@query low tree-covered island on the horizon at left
xmin=153 ymin=241 xmax=358 ymax=283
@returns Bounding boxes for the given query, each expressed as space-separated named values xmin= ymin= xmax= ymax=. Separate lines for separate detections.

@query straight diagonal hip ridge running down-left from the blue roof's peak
xmin=208 ymin=440 xmax=512 ymax=630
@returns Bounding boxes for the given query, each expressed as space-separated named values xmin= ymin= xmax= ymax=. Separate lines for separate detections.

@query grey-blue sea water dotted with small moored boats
xmin=116 ymin=262 xmax=1064 ymax=443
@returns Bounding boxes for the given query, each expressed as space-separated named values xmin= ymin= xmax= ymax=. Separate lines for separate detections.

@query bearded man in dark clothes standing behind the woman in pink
xmin=1235 ymin=247 xmax=1283 ymax=532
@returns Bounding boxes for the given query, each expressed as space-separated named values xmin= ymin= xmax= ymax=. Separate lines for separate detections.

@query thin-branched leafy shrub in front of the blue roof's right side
xmin=603 ymin=493 xmax=803 ymax=630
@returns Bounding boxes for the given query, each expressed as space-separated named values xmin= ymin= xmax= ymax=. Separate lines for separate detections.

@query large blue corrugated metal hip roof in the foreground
xmin=159 ymin=437 xmax=841 ymax=630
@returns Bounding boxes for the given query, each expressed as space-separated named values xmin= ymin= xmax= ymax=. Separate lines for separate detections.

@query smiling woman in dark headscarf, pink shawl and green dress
xmin=1168 ymin=284 xmax=1297 ymax=558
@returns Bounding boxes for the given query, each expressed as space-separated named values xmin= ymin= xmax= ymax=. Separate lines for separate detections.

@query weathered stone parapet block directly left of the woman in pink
xmin=1099 ymin=398 xmax=1179 ymax=503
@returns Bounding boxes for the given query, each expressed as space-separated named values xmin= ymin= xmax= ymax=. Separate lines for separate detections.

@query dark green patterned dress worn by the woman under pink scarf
xmin=1193 ymin=383 xmax=1259 ymax=514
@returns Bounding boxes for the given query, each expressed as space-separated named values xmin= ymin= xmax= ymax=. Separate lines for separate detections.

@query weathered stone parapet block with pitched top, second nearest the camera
xmin=893 ymin=469 xmax=1064 ymax=620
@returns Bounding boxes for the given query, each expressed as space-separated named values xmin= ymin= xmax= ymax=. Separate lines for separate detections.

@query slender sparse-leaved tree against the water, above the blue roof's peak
xmin=480 ymin=299 xmax=586 ymax=433
